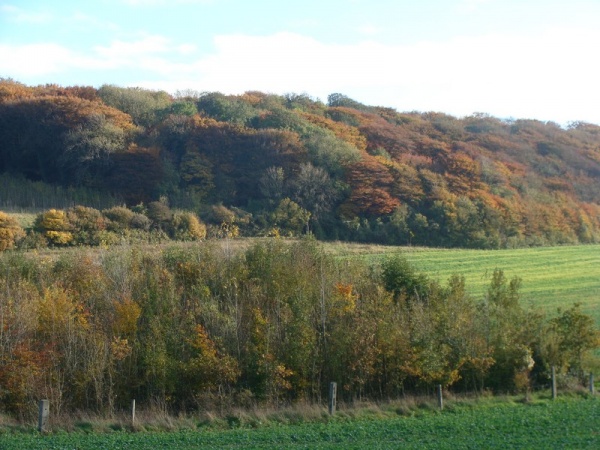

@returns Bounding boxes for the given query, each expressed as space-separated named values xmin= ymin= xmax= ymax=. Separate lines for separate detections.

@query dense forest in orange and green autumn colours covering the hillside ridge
xmin=0 ymin=79 xmax=600 ymax=249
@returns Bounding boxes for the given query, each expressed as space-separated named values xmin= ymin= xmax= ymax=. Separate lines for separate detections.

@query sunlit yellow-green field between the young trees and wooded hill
xmin=327 ymin=243 xmax=600 ymax=325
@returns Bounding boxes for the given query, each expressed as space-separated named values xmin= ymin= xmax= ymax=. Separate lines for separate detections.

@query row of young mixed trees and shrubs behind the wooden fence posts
xmin=0 ymin=239 xmax=599 ymax=415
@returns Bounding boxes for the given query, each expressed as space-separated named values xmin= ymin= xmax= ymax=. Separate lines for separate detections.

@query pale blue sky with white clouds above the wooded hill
xmin=0 ymin=0 xmax=600 ymax=125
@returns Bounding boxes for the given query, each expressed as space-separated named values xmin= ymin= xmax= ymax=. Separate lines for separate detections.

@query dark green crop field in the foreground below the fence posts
xmin=0 ymin=397 xmax=600 ymax=450
